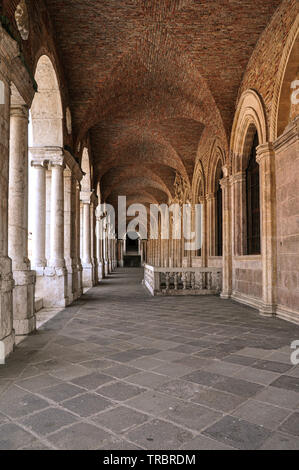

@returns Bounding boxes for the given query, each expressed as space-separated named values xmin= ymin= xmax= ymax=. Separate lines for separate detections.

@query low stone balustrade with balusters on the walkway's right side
xmin=144 ymin=264 xmax=222 ymax=295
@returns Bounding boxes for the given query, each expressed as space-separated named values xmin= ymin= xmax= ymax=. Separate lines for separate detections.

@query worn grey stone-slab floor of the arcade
xmin=0 ymin=269 xmax=299 ymax=450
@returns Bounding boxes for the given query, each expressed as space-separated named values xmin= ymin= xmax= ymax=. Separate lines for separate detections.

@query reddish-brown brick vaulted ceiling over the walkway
xmin=46 ymin=0 xmax=280 ymax=203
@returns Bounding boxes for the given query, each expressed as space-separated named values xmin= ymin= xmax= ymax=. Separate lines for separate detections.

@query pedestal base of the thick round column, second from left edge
xmin=13 ymin=271 xmax=36 ymax=336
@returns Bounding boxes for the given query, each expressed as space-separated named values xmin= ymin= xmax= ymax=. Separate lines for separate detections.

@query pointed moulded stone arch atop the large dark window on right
xmin=230 ymin=90 xmax=268 ymax=173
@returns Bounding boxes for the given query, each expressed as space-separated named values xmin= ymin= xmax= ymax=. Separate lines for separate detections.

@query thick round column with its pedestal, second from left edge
xmin=8 ymin=104 xmax=36 ymax=336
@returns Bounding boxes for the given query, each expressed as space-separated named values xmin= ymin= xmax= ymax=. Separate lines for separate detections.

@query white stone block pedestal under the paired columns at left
xmin=36 ymin=268 xmax=69 ymax=308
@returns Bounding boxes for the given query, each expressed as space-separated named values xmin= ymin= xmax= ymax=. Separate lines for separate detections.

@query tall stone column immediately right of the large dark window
xmin=256 ymin=143 xmax=277 ymax=315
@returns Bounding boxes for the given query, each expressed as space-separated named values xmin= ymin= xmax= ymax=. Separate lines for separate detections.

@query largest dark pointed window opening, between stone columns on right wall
xmin=246 ymin=132 xmax=261 ymax=255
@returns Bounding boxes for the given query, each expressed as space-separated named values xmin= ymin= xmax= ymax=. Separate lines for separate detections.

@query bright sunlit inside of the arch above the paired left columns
xmin=31 ymin=55 xmax=63 ymax=147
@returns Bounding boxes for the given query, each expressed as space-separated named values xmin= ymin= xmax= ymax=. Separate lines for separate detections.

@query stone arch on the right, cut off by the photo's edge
xmin=270 ymin=20 xmax=299 ymax=141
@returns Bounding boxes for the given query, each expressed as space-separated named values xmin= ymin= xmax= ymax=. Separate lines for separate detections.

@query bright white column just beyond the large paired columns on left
xmin=81 ymin=192 xmax=93 ymax=287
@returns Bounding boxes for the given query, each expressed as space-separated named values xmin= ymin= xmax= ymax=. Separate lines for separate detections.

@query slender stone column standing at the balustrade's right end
xmin=220 ymin=172 xmax=232 ymax=299
